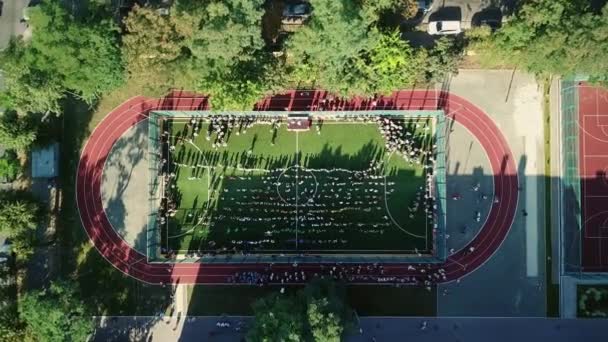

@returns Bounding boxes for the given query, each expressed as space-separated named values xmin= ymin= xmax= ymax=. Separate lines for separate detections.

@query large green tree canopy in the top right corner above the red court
xmin=486 ymin=0 xmax=608 ymax=81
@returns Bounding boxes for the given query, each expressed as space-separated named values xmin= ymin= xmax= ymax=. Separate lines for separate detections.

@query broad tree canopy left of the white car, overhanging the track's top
xmin=285 ymin=0 xmax=460 ymax=96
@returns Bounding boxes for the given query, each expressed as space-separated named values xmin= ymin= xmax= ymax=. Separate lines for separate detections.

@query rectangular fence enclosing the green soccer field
xmin=147 ymin=110 xmax=447 ymax=263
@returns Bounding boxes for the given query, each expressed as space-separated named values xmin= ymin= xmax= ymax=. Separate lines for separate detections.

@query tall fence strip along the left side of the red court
xmin=560 ymin=80 xmax=582 ymax=273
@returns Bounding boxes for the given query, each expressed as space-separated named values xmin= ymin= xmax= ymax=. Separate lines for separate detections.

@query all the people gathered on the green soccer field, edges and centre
xmin=158 ymin=114 xmax=437 ymax=253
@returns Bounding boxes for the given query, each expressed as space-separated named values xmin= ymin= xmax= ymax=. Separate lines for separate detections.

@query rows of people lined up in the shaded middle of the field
xmin=210 ymin=170 xmax=426 ymax=250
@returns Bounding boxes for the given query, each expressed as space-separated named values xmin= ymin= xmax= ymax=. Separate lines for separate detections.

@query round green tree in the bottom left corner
xmin=19 ymin=281 xmax=94 ymax=341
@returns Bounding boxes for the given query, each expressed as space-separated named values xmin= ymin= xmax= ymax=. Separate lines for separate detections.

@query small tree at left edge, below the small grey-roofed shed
xmin=0 ymin=193 xmax=41 ymax=259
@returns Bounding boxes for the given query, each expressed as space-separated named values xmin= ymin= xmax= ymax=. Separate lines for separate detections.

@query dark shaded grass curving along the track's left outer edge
xmin=55 ymin=93 xmax=171 ymax=315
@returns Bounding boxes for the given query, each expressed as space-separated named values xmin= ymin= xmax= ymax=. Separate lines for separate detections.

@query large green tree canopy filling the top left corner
xmin=2 ymin=0 xmax=123 ymax=114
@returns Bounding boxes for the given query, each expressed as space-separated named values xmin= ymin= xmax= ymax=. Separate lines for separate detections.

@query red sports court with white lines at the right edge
xmin=577 ymin=83 xmax=608 ymax=272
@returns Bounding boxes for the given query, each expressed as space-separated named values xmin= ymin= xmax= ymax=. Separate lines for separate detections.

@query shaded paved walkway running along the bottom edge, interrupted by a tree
xmin=93 ymin=316 xmax=607 ymax=342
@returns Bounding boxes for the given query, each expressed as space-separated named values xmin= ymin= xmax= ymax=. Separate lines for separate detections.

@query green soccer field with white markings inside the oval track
xmin=161 ymin=118 xmax=433 ymax=254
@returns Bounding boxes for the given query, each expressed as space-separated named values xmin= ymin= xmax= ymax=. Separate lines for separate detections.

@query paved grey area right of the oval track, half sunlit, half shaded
xmin=437 ymin=70 xmax=546 ymax=316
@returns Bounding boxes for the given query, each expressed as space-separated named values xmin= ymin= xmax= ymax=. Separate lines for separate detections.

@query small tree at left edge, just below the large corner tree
xmin=0 ymin=111 xmax=36 ymax=151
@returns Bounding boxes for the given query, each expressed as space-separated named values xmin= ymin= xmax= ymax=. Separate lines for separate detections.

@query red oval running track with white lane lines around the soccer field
xmin=76 ymin=90 xmax=518 ymax=284
